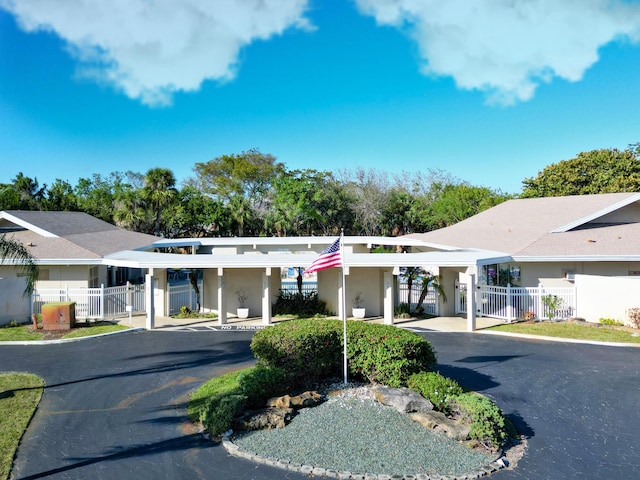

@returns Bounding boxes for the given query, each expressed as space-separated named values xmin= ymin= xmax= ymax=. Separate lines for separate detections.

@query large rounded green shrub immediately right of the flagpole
xmin=347 ymin=322 xmax=436 ymax=387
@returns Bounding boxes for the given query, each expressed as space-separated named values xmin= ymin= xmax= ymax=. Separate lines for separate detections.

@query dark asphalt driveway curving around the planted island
xmin=0 ymin=331 xmax=640 ymax=480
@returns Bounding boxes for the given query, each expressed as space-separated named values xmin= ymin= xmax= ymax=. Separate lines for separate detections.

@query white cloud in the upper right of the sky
xmin=355 ymin=0 xmax=640 ymax=105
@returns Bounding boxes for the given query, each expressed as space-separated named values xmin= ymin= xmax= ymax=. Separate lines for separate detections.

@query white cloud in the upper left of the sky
xmin=0 ymin=0 xmax=311 ymax=106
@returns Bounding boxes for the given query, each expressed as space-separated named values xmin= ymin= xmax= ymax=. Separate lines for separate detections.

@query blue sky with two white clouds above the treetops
xmin=0 ymin=0 xmax=640 ymax=193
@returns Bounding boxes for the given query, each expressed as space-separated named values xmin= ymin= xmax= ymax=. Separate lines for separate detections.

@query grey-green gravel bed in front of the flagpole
xmin=233 ymin=387 xmax=494 ymax=476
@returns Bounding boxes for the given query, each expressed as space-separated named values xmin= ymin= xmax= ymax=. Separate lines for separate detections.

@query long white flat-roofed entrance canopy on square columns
xmin=105 ymin=237 xmax=510 ymax=330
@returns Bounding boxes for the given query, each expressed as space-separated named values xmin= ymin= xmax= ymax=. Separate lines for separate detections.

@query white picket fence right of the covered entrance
xmin=456 ymin=284 xmax=576 ymax=321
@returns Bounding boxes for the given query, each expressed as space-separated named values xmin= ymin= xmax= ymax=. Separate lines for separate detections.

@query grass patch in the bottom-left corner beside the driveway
xmin=0 ymin=373 xmax=44 ymax=480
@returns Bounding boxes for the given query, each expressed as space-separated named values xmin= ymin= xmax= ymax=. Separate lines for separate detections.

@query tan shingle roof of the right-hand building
xmin=408 ymin=193 xmax=640 ymax=256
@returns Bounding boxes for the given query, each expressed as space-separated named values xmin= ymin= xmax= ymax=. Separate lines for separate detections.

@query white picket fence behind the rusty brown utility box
xmin=31 ymin=284 xmax=145 ymax=320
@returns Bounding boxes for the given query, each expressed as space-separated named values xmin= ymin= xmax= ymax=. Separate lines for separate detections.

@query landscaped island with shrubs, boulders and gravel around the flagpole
xmin=189 ymin=319 xmax=515 ymax=478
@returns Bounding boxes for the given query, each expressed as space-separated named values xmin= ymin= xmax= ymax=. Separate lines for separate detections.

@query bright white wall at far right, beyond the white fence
xmin=575 ymin=275 xmax=640 ymax=323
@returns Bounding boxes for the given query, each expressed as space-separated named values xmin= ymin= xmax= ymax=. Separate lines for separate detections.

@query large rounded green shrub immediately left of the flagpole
xmin=251 ymin=319 xmax=342 ymax=385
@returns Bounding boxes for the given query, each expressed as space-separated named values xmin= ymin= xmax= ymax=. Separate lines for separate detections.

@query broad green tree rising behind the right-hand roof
xmin=521 ymin=144 xmax=640 ymax=198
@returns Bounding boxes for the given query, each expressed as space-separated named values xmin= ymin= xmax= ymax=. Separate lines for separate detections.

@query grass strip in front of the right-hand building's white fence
xmin=488 ymin=322 xmax=640 ymax=343
